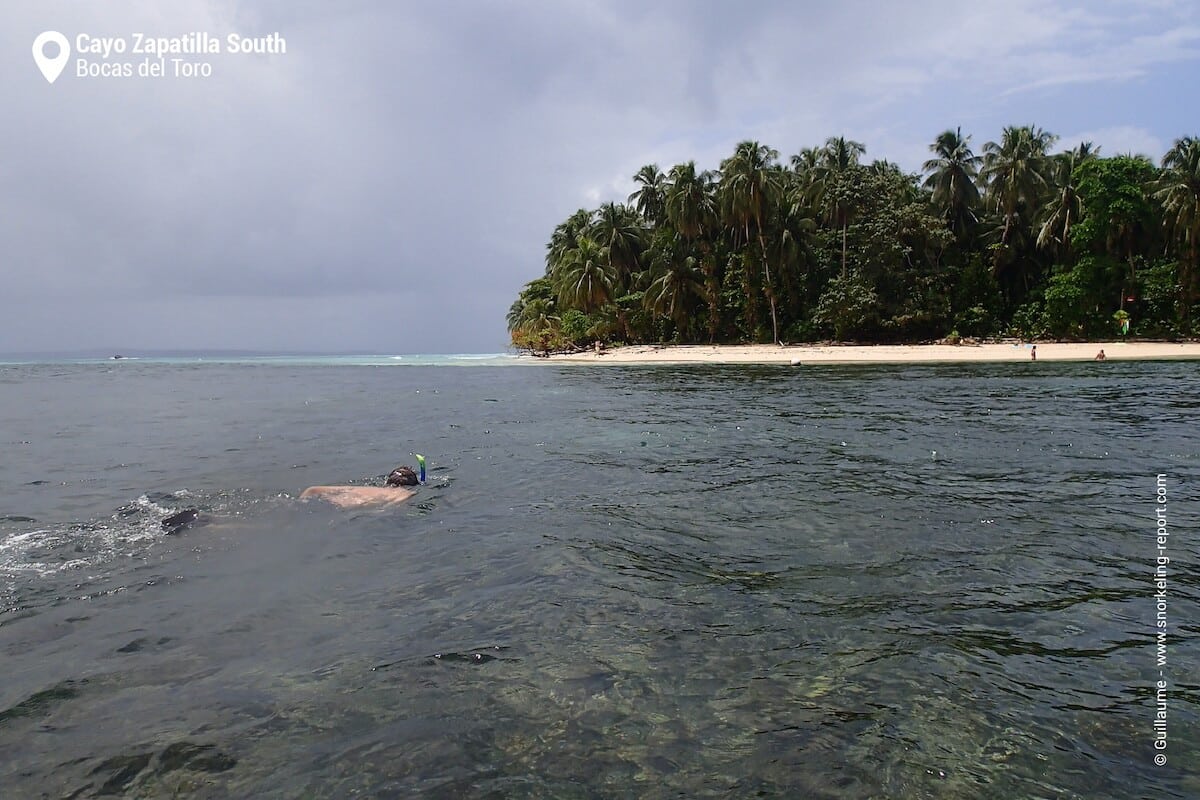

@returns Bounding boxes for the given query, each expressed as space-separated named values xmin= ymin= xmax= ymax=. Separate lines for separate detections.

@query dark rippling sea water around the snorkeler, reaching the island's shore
xmin=0 ymin=356 xmax=1200 ymax=799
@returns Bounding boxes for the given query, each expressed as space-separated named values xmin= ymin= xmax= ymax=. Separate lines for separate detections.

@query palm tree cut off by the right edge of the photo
xmin=1154 ymin=137 xmax=1200 ymax=321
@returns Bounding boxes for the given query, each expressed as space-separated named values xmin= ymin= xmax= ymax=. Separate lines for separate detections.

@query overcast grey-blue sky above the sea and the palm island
xmin=0 ymin=0 xmax=1200 ymax=354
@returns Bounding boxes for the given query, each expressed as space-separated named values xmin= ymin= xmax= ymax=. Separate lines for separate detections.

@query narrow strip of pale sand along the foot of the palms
xmin=547 ymin=342 xmax=1200 ymax=366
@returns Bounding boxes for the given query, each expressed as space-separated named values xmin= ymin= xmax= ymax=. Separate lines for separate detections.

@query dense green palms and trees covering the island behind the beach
xmin=508 ymin=127 xmax=1200 ymax=351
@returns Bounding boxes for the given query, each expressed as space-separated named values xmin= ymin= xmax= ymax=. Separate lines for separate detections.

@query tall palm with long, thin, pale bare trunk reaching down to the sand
xmin=720 ymin=142 xmax=782 ymax=342
